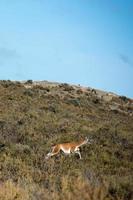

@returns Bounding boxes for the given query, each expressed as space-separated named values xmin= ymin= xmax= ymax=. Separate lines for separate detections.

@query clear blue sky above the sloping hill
xmin=0 ymin=0 xmax=133 ymax=98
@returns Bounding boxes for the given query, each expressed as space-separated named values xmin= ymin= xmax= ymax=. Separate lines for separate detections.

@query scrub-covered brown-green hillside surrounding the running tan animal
xmin=0 ymin=80 xmax=133 ymax=200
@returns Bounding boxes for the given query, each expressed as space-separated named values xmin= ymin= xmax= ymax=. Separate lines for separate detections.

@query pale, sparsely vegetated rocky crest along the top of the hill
xmin=22 ymin=80 xmax=133 ymax=115
